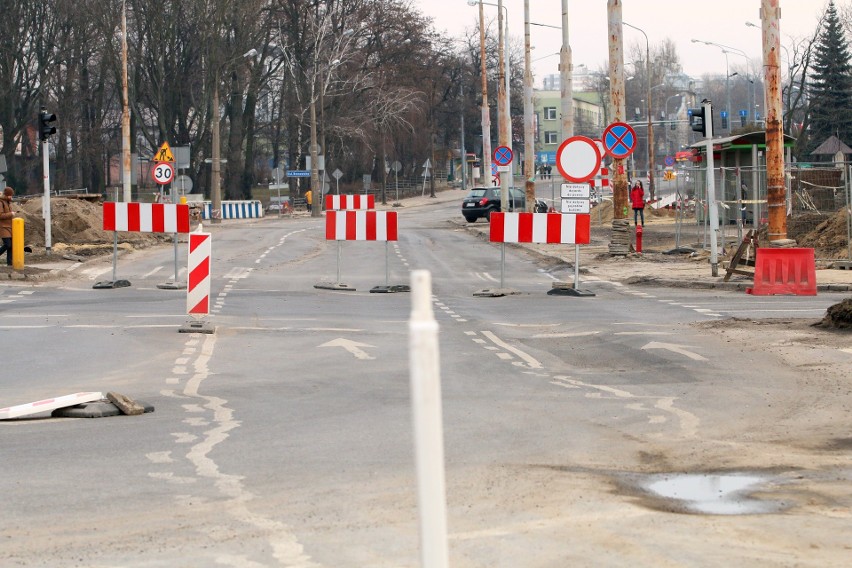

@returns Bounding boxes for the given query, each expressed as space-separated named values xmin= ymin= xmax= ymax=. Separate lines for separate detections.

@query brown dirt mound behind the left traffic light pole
xmin=12 ymin=197 xmax=169 ymax=254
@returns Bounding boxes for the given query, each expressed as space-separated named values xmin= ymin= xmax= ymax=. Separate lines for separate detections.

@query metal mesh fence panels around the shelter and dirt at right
xmin=655 ymin=164 xmax=852 ymax=260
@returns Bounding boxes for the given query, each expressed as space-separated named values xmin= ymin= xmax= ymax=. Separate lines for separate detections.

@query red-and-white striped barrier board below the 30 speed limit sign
xmin=103 ymin=201 xmax=189 ymax=233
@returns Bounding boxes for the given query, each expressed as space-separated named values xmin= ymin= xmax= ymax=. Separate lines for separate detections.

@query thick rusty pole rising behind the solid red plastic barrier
xmin=760 ymin=0 xmax=787 ymax=241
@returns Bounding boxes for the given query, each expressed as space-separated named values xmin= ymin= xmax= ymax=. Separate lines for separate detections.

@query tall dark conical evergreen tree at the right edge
xmin=808 ymin=0 xmax=852 ymax=154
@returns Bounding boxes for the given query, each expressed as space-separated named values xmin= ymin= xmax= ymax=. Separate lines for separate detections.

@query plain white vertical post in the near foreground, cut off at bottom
xmin=408 ymin=270 xmax=449 ymax=568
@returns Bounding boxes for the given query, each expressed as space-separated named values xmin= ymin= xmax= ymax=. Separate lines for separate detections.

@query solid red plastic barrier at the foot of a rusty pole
xmin=746 ymin=248 xmax=816 ymax=296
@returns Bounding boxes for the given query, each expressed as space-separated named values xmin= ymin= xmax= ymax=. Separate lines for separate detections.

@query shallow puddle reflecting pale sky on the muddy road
xmin=628 ymin=473 xmax=788 ymax=515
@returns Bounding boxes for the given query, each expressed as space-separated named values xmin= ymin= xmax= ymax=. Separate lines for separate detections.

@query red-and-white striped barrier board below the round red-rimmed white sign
xmin=491 ymin=212 xmax=591 ymax=245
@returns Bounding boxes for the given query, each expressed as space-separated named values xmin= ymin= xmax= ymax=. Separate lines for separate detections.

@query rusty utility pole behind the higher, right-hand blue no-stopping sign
xmin=607 ymin=0 xmax=630 ymax=255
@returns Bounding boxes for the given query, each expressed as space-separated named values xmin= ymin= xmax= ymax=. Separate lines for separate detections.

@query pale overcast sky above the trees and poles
xmin=411 ymin=0 xmax=832 ymax=82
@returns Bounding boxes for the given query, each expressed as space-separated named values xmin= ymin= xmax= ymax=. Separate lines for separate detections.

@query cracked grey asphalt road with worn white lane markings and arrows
xmin=0 ymin=196 xmax=852 ymax=567
